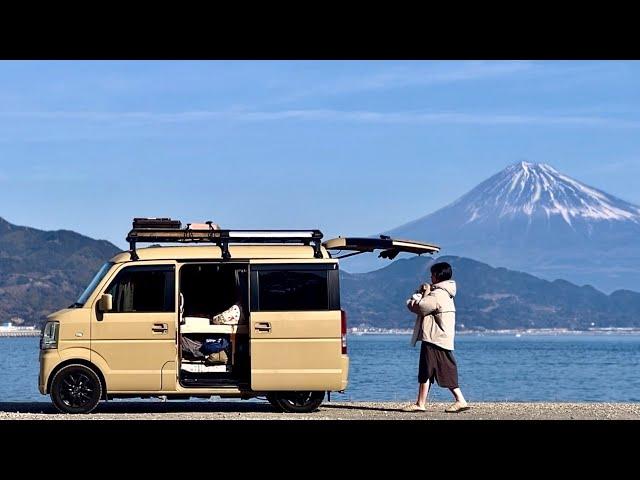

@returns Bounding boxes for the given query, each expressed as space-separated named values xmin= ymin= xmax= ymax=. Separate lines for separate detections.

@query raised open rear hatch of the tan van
xmin=322 ymin=235 xmax=440 ymax=260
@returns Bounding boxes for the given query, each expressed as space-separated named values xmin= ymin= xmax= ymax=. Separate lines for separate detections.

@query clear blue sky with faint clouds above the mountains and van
xmin=0 ymin=61 xmax=640 ymax=253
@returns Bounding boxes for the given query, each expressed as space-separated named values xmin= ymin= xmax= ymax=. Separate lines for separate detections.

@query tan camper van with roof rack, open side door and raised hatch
xmin=38 ymin=218 xmax=438 ymax=413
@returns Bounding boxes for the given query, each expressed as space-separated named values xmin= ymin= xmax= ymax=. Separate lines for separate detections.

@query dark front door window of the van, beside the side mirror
xmin=105 ymin=265 xmax=175 ymax=313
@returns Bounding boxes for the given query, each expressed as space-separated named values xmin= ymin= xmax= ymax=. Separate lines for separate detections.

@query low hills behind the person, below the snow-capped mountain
xmin=340 ymin=256 xmax=640 ymax=330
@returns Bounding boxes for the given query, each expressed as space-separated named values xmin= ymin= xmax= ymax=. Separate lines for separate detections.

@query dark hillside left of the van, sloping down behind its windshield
xmin=0 ymin=218 xmax=120 ymax=324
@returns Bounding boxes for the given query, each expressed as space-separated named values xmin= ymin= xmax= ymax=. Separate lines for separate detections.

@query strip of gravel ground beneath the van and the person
xmin=0 ymin=401 xmax=640 ymax=420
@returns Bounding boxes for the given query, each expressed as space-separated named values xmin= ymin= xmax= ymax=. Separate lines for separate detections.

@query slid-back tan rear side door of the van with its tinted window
xmin=249 ymin=260 xmax=342 ymax=391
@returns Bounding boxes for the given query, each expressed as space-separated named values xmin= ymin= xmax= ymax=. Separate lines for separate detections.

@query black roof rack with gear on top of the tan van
xmin=127 ymin=218 xmax=323 ymax=260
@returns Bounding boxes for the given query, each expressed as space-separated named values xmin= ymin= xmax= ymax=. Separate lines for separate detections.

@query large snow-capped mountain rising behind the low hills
xmin=385 ymin=162 xmax=640 ymax=291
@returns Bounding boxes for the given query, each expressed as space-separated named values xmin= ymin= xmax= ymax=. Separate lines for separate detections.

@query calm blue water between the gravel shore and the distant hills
xmin=0 ymin=335 xmax=640 ymax=402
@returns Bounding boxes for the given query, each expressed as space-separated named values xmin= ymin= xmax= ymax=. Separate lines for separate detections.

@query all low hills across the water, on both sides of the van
xmin=0 ymin=215 xmax=640 ymax=329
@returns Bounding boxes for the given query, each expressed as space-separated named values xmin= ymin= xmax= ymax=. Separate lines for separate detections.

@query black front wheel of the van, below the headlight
xmin=51 ymin=364 xmax=102 ymax=413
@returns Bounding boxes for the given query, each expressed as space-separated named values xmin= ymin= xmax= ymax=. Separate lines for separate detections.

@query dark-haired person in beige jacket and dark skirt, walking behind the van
xmin=403 ymin=262 xmax=470 ymax=413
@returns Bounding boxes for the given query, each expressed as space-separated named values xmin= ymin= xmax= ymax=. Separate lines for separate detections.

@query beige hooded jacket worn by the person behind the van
xmin=407 ymin=280 xmax=456 ymax=350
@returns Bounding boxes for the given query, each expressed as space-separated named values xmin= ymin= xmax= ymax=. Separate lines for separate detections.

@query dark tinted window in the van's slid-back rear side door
xmin=251 ymin=265 xmax=340 ymax=311
